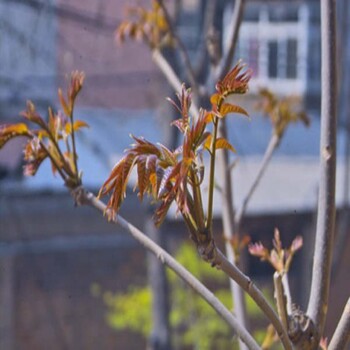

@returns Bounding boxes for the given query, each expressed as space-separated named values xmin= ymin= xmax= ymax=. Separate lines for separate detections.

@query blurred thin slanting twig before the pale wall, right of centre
xmin=235 ymin=133 xmax=280 ymax=231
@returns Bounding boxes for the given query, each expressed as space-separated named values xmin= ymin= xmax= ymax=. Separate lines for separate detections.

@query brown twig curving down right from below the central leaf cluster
xmin=211 ymin=248 xmax=292 ymax=350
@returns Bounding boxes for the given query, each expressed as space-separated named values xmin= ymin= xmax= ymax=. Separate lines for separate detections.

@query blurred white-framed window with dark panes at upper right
xmin=228 ymin=3 xmax=309 ymax=94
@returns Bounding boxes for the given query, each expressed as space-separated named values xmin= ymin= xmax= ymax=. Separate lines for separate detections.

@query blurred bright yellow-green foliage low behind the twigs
xmin=98 ymin=243 xmax=274 ymax=350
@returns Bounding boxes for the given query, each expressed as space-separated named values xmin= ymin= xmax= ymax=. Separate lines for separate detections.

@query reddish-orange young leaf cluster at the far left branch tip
xmin=0 ymin=71 xmax=88 ymax=188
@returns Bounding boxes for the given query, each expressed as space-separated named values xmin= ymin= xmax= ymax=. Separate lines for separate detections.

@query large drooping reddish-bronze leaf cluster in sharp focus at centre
xmin=99 ymin=63 xmax=250 ymax=235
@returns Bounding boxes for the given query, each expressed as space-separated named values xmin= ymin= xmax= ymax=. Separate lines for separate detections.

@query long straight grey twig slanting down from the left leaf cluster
xmin=73 ymin=187 xmax=260 ymax=350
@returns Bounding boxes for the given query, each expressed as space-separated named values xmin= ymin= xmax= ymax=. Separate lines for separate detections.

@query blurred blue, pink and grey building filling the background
xmin=0 ymin=0 xmax=349 ymax=350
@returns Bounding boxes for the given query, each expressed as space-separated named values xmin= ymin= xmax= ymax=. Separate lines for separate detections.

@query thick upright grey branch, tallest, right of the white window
xmin=307 ymin=0 xmax=337 ymax=337
